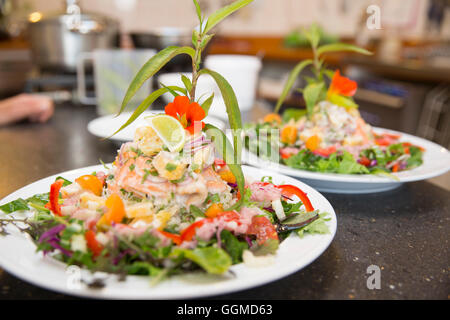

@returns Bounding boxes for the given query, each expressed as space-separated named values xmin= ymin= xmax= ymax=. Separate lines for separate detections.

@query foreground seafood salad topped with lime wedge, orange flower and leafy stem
xmin=0 ymin=0 xmax=330 ymax=283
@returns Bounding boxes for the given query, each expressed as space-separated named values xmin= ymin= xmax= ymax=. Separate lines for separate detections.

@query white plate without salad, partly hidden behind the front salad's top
xmin=87 ymin=110 xmax=225 ymax=144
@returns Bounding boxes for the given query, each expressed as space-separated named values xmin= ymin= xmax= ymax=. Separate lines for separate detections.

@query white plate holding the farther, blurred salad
xmin=242 ymin=128 xmax=450 ymax=193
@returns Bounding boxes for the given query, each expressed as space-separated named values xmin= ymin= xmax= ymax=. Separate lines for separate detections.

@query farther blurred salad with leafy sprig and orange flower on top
xmin=243 ymin=25 xmax=424 ymax=179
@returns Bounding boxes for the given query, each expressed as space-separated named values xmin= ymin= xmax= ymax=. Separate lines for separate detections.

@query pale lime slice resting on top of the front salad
xmin=146 ymin=114 xmax=186 ymax=152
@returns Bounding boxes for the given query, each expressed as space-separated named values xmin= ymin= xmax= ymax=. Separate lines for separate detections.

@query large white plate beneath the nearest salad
xmin=0 ymin=165 xmax=336 ymax=299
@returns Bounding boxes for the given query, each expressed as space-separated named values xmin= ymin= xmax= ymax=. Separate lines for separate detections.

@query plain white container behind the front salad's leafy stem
xmin=205 ymin=54 xmax=262 ymax=111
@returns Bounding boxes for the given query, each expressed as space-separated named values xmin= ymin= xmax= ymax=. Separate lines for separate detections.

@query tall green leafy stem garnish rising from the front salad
xmin=113 ymin=0 xmax=253 ymax=209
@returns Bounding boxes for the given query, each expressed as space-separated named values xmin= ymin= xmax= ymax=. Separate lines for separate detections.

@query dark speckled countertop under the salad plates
xmin=0 ymin=104 xmax=450 ymax=299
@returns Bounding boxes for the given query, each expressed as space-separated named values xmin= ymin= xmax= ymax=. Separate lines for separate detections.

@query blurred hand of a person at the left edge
xmin=0 ymin=93 xmax=54 ymax=126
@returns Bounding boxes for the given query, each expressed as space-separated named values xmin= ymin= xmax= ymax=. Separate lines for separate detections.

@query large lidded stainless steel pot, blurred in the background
xmin=28 ymin=1 xmax=119 ymax=72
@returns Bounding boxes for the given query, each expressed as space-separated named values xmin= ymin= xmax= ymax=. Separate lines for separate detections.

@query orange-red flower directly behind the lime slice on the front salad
xmin=164 ymin=96 xmax=206 ymax=134
